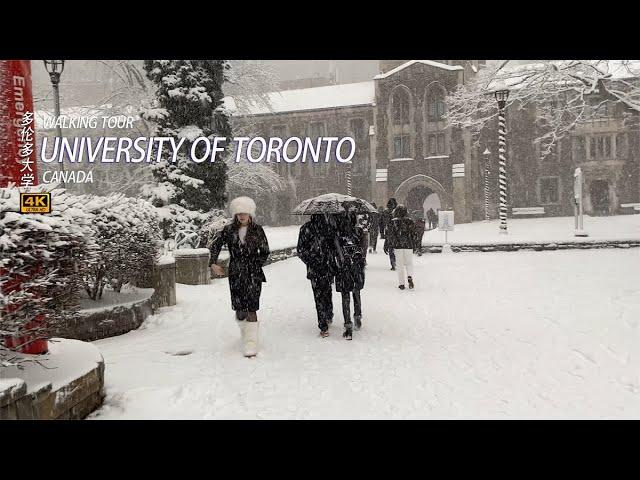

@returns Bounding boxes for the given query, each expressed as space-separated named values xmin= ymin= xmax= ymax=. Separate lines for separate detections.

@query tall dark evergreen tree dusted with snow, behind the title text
xmin=143 ymin=60 xmax=231 ymax=212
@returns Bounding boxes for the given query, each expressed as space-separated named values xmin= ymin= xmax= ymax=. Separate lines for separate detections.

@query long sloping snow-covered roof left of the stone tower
xmin=223 ymin=81 xmax=375 ymax=115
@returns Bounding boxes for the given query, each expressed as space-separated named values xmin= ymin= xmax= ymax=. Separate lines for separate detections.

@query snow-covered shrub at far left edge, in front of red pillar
xmin=0 ymin=187 xmax=97 ymax=362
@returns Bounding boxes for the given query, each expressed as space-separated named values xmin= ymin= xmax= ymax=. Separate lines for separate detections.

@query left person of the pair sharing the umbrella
xmin=297 ymin=214 xmax=336 ymax=337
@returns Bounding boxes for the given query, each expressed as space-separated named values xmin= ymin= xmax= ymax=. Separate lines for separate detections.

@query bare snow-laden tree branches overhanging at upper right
xmin=446 ymin=60 xmax=640 ymax=156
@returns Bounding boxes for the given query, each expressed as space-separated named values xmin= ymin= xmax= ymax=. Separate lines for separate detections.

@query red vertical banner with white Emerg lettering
xmin=0 ymin=60 xmax=38 ymax=191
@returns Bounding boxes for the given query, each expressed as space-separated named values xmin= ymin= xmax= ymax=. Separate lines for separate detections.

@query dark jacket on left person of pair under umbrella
xmin=297 ymin=215 xmax=336 ymax=281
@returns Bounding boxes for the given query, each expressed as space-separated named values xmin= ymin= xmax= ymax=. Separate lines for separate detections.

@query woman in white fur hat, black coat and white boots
xmin=209 ymin=197 xmax=269 ymax=357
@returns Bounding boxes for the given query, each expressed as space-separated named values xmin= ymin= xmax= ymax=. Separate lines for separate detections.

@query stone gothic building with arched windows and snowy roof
xmin=226 ymin=60 xmax=640 ymax=223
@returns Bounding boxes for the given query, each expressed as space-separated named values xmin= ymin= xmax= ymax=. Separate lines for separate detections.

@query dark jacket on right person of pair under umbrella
xmin=335 ymin=215 xmax=367 ymax=292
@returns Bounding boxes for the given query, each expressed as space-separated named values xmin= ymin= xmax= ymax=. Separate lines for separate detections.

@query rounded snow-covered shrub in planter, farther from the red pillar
xmin=81 ymin=194 xmax=160 ymax=300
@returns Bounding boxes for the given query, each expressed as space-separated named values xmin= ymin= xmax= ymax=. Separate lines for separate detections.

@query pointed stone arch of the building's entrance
xmin=394 ymin=175 xmax=452 ymax=218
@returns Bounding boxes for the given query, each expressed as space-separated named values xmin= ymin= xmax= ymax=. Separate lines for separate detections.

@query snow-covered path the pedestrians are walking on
xmin=92 ymin=242 xmax=640 ymax=419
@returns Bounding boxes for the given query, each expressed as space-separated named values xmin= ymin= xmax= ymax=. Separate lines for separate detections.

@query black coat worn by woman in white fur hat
xmin=209 ymin=222 xmax=269 ymax=312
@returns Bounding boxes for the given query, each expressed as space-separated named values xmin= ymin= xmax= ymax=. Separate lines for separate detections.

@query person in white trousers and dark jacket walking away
xmin=384 ymin=205 xmax=416 ymax=290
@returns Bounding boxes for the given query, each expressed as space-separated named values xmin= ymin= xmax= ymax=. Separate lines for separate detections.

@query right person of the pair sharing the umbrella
xmin=335 ymin=213 xmax=364 ymax=340
